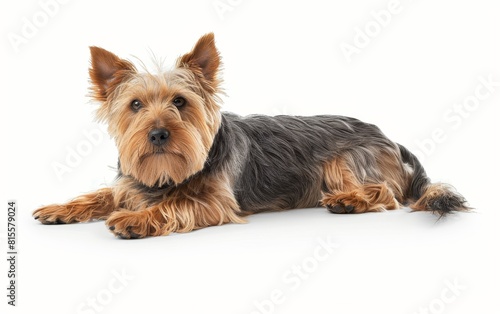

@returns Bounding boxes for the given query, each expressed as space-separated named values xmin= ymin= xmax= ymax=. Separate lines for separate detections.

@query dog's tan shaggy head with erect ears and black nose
xmin=89 ymin=34 xmax=221 ymax=187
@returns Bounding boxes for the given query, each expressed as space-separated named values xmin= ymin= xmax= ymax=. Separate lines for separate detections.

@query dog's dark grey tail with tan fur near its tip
xmin=398 ymin=144 xmax=471 ymax=217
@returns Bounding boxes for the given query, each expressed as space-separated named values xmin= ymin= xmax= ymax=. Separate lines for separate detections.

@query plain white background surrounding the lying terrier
xmin=0 ymin=0 xmax=500 ymax=314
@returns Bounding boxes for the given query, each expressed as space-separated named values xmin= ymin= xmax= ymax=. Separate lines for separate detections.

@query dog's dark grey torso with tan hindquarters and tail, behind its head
xmin=218 ymin=113 xmax=465 ymax=214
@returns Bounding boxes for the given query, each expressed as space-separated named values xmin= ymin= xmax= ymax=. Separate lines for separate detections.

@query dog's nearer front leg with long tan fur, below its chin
xmin=106 ymin=177 xmax=245 ymax=239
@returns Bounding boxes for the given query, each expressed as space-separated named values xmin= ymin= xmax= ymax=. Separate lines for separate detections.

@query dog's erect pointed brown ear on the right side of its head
xmin=177 ymin=33 xmax=221 ymax=89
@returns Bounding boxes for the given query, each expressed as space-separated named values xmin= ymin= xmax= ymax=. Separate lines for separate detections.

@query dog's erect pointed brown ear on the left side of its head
xmin=89 ymin=47 xmax=136 ymax=101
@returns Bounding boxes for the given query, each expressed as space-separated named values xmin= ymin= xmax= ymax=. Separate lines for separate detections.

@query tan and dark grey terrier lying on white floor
xmin=33 ymin=33 xmax=470 ymax=239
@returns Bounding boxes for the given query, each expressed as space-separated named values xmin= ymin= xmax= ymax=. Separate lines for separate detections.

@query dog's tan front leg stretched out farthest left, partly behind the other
xmin=33 ymin=188 xmax=115 ymax=224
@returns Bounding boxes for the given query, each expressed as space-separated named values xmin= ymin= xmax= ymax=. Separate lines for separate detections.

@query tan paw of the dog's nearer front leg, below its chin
xmin=106 ymin=211 xmax=150 ymax=239
